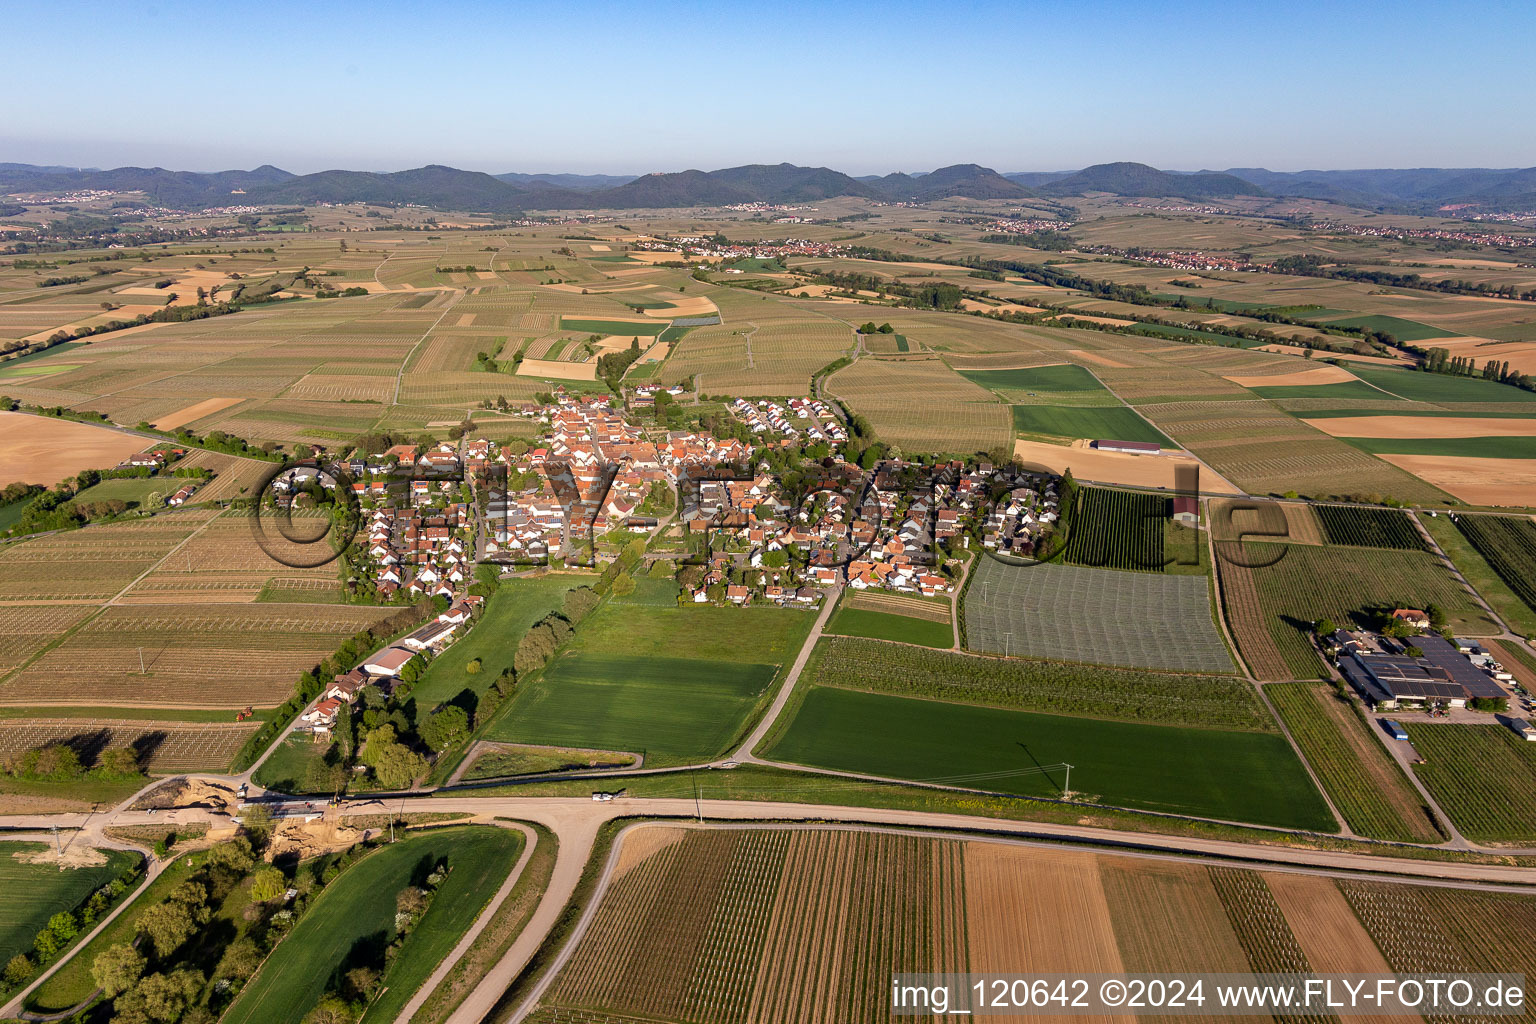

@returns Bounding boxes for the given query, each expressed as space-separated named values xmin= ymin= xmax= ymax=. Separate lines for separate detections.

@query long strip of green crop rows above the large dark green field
xmin=811 ymin=637 xmax=1275 ymax=732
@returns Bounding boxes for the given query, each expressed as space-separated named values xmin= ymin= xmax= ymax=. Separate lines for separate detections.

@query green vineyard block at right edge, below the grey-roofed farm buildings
xmin=1407 ymin=715 xmax=1536 ymax=846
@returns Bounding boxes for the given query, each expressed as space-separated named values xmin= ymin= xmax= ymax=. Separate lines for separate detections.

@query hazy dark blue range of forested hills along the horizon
xmin=12 ymin=163 xmax=1536 ymax=216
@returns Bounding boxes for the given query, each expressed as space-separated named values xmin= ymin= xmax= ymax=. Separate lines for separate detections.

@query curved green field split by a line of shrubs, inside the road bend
xmin=221 ymin=827 xmax=522 ymax=1024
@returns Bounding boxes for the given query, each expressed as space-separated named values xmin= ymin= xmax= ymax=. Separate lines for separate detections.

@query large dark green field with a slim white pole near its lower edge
xmin=766 ymin=686 xmax=1335 ymax=832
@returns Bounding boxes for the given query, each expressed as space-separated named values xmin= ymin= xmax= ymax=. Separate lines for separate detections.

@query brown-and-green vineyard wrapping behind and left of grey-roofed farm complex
xmin=1217 ymin=542 xmax=1499 ymax=679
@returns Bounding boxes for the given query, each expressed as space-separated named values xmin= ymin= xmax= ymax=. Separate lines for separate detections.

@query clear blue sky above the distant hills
xmin=0 ymin=0 xmax=1536 ymax=173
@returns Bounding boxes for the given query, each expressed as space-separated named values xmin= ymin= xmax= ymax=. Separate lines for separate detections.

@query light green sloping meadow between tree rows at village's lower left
xmin=415 ymin=573 xmax=583 ymax=709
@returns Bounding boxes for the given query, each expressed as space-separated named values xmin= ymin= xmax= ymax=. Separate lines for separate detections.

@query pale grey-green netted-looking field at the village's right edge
xmin=965 ymin=557 xmax=1233 ymax=674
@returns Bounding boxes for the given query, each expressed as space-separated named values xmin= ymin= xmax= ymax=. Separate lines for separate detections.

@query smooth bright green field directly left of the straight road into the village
xmin=485 ymin=657 xmax=779 ymax=768
